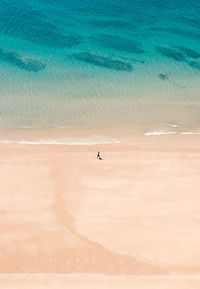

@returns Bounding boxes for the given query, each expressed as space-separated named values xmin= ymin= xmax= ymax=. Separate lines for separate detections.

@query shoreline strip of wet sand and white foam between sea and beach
xmin=0 ymin=124 xmax=200 ymax=146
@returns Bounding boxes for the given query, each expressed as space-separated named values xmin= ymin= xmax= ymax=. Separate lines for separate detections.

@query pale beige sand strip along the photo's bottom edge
xmin=0 ymin=275 xmax=200 ymax=289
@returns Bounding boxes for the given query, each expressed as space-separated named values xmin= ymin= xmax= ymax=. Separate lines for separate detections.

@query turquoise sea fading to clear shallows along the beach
xmin=0 ymin=0 xmax=200 ymax=141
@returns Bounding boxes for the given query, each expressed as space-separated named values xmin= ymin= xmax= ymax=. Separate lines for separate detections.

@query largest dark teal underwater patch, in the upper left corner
xmin=0 ymin=2 xmax=81 ymax=48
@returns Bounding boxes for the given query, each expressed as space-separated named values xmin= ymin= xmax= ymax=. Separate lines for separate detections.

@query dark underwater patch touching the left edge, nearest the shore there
xmin=0 ymin=48 xmax=46 ymax=72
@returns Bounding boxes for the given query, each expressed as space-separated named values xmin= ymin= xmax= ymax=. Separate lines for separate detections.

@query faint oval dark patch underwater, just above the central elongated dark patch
xmin=90 ymin=34 xmax=144 ymax=54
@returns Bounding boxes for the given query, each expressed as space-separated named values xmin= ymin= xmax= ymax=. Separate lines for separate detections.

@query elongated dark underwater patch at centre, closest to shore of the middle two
xmin=73 ymin=52 xmax=133 ymax=71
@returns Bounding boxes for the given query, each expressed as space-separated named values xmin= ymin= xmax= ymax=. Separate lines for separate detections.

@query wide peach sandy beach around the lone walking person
xmin=0 ymin=135 xmax=200 ymax=289
